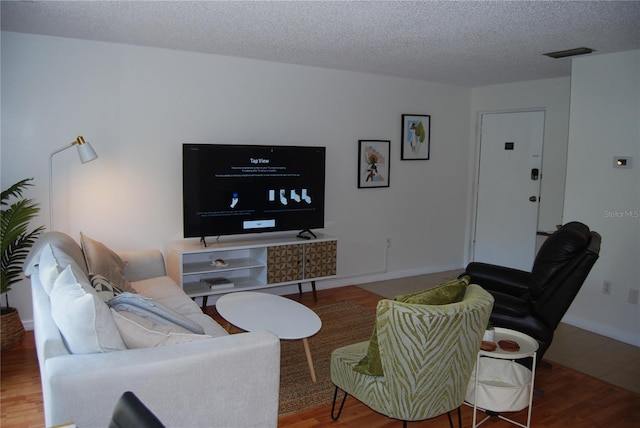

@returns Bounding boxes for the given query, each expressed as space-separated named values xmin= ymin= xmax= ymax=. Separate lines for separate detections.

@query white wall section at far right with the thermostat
xmin=564 ymin=50 xmax=640 ymax=346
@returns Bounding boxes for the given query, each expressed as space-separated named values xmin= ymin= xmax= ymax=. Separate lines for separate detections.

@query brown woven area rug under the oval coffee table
xmin=279 ymin=301 xmax=375 ymax=416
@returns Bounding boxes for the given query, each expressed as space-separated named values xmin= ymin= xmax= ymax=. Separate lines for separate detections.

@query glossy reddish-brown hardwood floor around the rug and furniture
xmin=0 ymin=286 xmax=640 ymax=428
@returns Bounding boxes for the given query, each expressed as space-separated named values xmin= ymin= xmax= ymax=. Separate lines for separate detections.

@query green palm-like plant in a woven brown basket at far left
xmin=0 ymin=178 xmax=44 ymax=349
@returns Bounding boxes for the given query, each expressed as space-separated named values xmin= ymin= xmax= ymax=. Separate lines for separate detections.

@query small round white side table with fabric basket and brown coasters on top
xmin=465 ymin=327 xmax=538 ymax=428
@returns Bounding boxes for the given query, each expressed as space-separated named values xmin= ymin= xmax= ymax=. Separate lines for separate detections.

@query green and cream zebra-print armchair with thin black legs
xmin=331 ymin=284 xmax=493 ymax=426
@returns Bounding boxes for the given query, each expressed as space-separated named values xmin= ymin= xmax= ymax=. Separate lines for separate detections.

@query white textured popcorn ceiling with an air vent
xmin=1 ymin=1 xmax=640 ymax=87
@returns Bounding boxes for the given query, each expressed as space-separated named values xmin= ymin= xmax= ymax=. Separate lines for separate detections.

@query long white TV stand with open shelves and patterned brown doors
xmin=167 ymin=234 xmax=337 ymax=306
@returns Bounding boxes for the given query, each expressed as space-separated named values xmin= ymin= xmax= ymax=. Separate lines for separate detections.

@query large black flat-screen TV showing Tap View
xmin=182 ymin=144 xmax=325 ymax=238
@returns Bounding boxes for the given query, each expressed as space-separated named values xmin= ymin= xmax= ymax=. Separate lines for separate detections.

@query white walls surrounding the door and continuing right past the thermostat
xmin=469 ymin=62 xmax=640 ymax=345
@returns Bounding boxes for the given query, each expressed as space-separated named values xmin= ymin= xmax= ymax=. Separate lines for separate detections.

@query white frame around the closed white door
xmin=465 ymin=107 xmax=547 ymax=266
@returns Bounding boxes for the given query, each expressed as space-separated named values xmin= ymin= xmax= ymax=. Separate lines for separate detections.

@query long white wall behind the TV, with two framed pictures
xmin=1 ymin=32 xmax=470 ymax=320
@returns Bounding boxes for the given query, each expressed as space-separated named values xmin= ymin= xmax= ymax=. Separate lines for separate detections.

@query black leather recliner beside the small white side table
xmin=461 ymin=222 xmax=601 ymax=363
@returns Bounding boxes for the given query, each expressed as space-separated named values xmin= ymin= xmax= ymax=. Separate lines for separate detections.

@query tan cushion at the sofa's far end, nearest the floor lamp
xmin=80 ymin=233 xmax=135 ymax=293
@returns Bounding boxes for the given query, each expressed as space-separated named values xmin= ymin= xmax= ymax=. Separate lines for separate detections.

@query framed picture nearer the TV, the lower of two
xmin=358 ymin=140 xmax=391 ymax=189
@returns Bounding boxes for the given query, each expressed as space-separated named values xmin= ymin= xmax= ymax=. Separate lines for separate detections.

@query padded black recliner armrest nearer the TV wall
xmin=462 ymin=262 xmax=531 ymax=297
